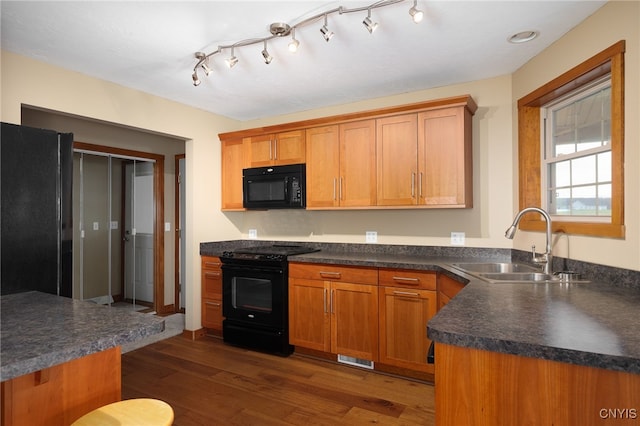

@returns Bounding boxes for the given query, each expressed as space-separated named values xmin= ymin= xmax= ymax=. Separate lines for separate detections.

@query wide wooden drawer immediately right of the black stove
xmin=289 ymin=263 xmax=378 ymax=285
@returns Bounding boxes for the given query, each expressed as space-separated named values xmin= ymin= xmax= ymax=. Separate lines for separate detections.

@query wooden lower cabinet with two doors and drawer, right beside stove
xmin=289 ymin=263 xmax=378 ymax=362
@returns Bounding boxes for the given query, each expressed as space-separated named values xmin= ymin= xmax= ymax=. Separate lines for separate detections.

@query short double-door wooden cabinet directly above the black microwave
xmin=248 ymin=130 xmax=305 ymax=167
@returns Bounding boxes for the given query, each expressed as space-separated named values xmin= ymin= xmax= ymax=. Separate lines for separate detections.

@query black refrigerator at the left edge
xmin=0 ymin=123 xmax=73 ymax=297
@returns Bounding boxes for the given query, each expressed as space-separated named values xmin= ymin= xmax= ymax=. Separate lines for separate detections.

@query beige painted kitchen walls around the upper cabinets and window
xmin=1 ymin=2 xmax=640 ymax=330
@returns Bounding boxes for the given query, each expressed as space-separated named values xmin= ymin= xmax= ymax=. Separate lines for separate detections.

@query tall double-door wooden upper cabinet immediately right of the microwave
xmin=307 ymin=120 xmax=376 ymax=209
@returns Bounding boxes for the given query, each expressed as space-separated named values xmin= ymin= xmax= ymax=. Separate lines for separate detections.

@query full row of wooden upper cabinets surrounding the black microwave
xmin=220 ymin=95 xmax=478 ymax=210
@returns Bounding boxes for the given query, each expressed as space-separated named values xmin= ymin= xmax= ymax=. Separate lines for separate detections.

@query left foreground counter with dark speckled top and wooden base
xmin=0 ymin=291 xmax=164 ymax=426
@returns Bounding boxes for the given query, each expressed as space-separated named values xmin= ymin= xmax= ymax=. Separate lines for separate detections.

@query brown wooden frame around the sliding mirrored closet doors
xmin=73 ymin=141 xmax=168 ymax=314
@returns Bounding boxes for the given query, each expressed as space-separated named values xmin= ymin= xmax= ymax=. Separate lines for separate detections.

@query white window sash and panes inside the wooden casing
xmin=541 ymin=75 xmax=611 ymax=223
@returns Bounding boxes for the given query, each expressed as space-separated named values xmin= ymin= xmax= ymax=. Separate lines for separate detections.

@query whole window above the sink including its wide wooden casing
xmin=518 ymin=41 xmax=625 ymax=238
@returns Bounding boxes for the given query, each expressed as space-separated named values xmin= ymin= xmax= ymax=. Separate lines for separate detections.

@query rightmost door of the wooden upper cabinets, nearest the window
xmin=418 ymin=107 xmax=473 ymax=207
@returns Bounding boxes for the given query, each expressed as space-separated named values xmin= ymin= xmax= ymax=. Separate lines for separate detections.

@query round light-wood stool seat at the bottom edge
xmin=71 ymin=398 xmax=173 ymax=426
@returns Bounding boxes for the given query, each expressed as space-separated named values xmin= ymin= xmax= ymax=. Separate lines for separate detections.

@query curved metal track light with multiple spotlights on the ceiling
xmin=191 ymin=0 xmax=424 ymax=86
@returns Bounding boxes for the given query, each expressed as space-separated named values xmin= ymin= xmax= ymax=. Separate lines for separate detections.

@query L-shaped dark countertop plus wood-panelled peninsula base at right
xmin=200 ymin=241 xmax=640 ymax=425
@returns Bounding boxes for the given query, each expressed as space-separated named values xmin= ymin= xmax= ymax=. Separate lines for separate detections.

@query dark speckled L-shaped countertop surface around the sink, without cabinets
xmin=200 ymin=241 xmax=640 ymax=374
